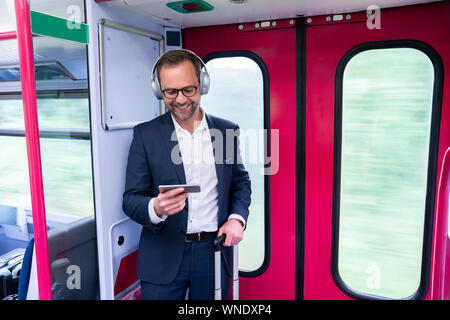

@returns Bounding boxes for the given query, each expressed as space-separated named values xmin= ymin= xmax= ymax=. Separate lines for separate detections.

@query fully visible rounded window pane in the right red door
xmin=333 ymin=47 xmax=435 ymax=299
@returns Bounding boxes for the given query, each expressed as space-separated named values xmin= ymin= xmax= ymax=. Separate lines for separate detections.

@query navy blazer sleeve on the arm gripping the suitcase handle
xmin=230 ymin=127 xmax=252 ymax=225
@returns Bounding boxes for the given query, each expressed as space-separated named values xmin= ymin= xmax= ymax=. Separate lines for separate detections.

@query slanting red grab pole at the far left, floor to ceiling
xmin=15 ymin=0 xmax=52 ymax=300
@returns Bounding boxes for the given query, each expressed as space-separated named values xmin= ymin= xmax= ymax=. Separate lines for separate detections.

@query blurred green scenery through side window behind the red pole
xmin=0 ymin=93 xmax=94 ymax=217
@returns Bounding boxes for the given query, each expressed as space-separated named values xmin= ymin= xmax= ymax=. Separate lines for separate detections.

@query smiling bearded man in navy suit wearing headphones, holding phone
xmin=123 ymin=50 xmax=251 ymax=300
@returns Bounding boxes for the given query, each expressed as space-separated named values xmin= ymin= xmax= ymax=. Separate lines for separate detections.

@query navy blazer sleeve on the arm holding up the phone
xmin=122 ymin=126 xmax=163 ymax=231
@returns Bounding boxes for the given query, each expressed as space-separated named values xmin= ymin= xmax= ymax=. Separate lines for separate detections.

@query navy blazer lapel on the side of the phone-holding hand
xmin=160 ymin=112 xmax=186 ymax=184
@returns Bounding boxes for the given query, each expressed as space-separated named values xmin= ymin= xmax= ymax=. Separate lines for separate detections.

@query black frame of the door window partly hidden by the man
xmin=202 ymin=50 xmax=271 ymax=278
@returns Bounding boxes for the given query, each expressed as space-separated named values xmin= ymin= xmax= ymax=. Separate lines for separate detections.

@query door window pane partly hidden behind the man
xmin=201 ymin=52 xmax=269 ymax=276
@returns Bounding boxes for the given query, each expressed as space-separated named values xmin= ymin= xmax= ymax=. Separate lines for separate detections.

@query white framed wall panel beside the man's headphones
xmin=99 ymin=19 xmax=164 ymax=130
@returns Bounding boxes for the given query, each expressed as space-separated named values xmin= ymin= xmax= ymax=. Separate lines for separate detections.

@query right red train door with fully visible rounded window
xmin=304 ymin=2 xmax=450 ymax=299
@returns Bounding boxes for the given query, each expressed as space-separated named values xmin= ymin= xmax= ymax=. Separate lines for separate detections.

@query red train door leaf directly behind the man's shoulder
xmin=183 ymin=19 xmax=296 ymax=299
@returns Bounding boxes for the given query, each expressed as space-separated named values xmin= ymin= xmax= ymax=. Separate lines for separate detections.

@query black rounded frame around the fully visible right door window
xmin=331 ymin=39 xmax=444 ymax=300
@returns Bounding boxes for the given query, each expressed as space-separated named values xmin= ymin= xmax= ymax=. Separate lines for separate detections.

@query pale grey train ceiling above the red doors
xmin=104 ymin=0 xmax=442 ymax=28
